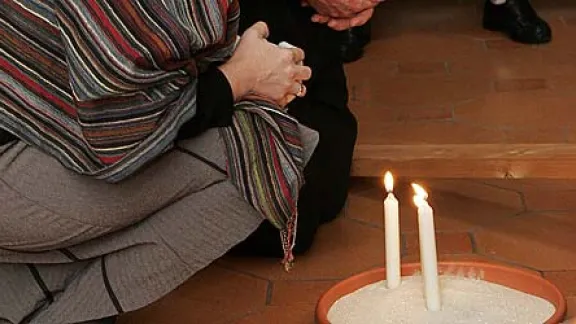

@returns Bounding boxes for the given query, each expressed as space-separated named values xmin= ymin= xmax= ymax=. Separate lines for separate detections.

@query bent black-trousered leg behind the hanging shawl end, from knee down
xmin=232 ymin=99 xmax=357 ymax=257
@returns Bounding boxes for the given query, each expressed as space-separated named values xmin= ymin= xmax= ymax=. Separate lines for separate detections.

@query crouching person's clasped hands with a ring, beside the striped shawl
xmin=220 ymin=22 xmax=312 ymax=107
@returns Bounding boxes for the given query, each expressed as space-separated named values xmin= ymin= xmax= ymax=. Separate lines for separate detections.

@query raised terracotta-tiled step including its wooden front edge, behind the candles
xmin=347 ymin=0 xmax=576 ymax=178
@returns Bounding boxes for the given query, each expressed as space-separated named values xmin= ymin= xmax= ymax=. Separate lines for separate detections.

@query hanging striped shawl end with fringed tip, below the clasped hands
xmin=221 ymin=101 xmax=304 ymax=270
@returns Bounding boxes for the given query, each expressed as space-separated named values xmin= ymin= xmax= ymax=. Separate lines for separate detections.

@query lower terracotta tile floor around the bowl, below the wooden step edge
xmin=121 ymin=178 xmax=576 ymax=324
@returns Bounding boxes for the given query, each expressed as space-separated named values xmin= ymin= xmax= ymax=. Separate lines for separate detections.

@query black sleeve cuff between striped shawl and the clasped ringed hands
xmin=178 ymin=66 xmax=234 ymax=139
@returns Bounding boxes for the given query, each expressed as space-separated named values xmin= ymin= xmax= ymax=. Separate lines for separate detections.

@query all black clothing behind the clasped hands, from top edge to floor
xmin=232 ymin=0 xmax=357 ymax=257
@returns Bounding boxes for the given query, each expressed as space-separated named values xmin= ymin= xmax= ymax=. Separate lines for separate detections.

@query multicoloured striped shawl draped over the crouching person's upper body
xmin=0 ymin=0 xmax=239 ymax=182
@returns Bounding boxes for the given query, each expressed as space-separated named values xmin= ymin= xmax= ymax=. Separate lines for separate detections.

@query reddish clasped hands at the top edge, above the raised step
xmin=302 ymin=0 xmax=383 ymax=18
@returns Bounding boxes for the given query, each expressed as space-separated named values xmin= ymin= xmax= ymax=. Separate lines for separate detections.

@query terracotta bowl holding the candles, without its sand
xmin=316 ymin=262 xmax=566 ymax=324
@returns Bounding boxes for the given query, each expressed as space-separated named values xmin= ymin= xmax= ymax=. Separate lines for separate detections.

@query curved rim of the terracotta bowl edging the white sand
xmin=315 ymin=261 xmax=567 ymax=324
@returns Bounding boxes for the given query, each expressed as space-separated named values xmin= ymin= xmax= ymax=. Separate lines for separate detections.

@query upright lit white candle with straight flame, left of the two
xmin=384 ymin=172 xmax=401 ymax=289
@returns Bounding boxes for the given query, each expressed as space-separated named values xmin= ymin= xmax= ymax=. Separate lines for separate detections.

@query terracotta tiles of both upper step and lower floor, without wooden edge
xmin=121 ymin=0 xmax=576 ymax=324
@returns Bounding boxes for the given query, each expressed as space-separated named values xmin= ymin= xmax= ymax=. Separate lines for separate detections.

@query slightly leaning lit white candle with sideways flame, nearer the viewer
xmin=412 ymin=184 xmax=441 ymax=311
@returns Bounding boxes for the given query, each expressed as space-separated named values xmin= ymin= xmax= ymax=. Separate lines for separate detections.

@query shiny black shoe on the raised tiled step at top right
xmin=483 ymin=0 xmax=552 ymax=44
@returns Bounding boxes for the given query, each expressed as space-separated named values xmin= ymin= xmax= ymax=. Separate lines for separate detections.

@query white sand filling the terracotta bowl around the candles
xmin=328 ymin=275 xmax=555 ymax=324
